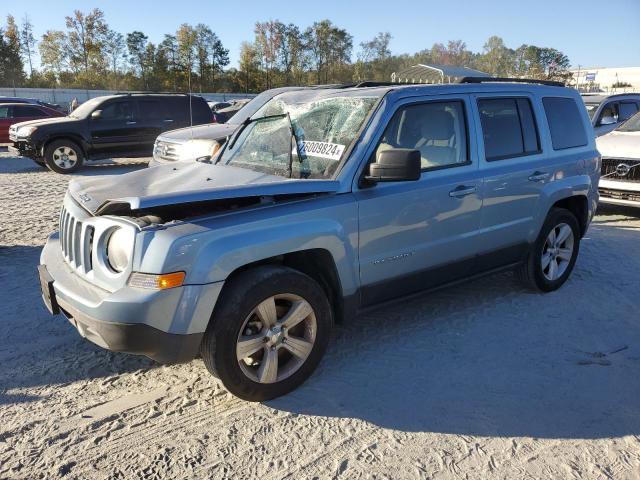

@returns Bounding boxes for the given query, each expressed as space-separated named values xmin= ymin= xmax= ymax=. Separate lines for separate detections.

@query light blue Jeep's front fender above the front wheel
xmin=134 ymin=194 xmax=359 ymax=295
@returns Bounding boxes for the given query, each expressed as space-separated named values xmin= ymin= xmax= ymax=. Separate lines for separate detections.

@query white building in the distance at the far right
xmin=571 ymin=67 xmax=640 ymax=93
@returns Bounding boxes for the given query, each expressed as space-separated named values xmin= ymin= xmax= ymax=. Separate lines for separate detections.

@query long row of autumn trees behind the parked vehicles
xmin=0 ymin=8 xmax=570 ymax=92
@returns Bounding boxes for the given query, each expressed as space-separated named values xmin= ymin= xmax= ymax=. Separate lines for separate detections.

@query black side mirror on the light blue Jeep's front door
xmin=365 ymin=148 xmax=421 ymax=183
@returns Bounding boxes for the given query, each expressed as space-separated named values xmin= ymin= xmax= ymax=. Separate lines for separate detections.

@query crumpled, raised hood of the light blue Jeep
xmin=69 ymin=163 xmax=340 ymax=215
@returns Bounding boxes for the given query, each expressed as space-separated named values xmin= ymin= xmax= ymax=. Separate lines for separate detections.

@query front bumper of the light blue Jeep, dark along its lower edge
xmin=40 ymin=234 xmax=222 ymax=363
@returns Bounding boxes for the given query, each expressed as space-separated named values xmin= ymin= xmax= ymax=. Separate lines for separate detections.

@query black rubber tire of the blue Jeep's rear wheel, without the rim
xmin=529 ymin=208 xmax=580 ymax=292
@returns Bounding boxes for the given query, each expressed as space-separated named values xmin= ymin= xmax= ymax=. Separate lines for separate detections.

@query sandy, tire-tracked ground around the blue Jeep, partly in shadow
xmin=0 ymin=153 xmax=640 ymax=479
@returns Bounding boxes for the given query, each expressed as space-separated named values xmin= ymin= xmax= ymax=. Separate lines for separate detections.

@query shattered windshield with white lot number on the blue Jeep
xmin=219 ymin=94 xmax=378 ymax=178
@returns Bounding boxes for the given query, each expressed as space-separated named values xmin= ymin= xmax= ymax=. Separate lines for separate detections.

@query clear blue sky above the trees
xmin=0 ymin=0 xmax=640 ymax=67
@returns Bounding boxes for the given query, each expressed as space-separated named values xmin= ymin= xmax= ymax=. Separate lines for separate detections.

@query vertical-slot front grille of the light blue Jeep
xmin=60 ymin=206 xmax=94 ymax=273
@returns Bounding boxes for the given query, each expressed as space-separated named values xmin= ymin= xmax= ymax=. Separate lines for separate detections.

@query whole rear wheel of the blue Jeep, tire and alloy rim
xmin=516 ymin=208 xmax=580 ymax=292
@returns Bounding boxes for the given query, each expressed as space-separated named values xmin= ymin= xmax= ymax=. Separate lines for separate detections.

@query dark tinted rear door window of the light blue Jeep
xmin=478 ymin=98 xmax=540 ymax=161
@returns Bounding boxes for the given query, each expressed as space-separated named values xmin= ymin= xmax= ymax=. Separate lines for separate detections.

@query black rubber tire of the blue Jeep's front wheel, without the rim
xmin=204 ymin=267 xmax=333 ymax=401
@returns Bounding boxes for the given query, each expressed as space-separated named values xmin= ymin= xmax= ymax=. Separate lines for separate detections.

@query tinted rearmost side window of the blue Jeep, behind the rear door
xmin=542 ymin=97 xmax=587 ymax=150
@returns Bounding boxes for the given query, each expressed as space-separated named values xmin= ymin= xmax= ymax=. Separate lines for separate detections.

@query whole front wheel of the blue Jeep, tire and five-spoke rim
xmin=201 ymin=266 xmax=333 ymax=402
